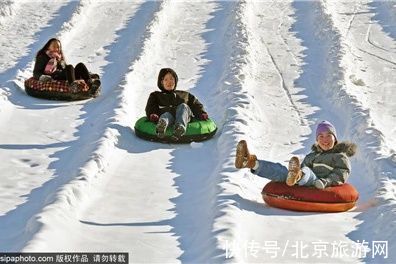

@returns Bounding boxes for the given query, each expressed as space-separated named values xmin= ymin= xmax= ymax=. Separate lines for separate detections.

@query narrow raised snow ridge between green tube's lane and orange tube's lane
xmin=206 ymin=1 xmax=258 ymax=262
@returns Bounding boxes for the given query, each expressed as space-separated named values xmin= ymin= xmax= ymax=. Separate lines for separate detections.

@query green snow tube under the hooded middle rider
xmin=135 ymin=116 xmax=217 ymax=143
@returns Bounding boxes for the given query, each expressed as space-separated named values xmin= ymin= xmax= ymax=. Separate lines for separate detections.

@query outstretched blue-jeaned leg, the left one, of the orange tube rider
xmin=251 ymin=160 xmax=288 ymax=182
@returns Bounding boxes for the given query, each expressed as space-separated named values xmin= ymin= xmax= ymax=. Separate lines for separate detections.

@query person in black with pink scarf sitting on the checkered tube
xmin=27 ymin=38 xmax=101 ymax=97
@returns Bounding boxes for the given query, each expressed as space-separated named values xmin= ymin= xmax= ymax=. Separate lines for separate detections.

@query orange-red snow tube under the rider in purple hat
xmin=261 ymin=181 xmax=359 ymax=212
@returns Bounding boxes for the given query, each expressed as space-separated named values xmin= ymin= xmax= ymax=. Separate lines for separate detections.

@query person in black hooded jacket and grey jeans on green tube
xmin=146 ymin=68 xmax=209 ymax=142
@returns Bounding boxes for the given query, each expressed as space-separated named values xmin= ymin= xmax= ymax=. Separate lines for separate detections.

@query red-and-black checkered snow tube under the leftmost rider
xmin=25 ymin=74 xmax=100 ymax=101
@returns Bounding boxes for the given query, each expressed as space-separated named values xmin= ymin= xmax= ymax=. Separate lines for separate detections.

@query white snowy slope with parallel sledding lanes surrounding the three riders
xmin=0 ymin=0 xmax=396 ymax=263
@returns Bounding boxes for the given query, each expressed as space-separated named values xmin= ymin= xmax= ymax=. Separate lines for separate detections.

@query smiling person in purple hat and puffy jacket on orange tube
xmin=235 ymin=121 xmax=356 ymax=189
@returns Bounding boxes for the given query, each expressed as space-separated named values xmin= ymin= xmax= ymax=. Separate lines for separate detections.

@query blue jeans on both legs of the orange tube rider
xmin=251 ymin=160 xmax=318 ymax=186
